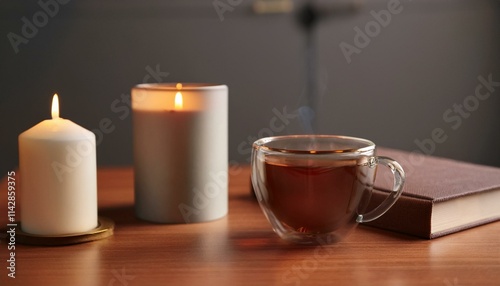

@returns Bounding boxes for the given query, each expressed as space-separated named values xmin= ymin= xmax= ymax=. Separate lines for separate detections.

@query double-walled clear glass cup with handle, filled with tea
xmin=252 ymin=135 xmax=405 ymax=244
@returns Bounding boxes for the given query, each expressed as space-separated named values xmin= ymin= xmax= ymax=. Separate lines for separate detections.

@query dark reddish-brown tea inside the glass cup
xmin=265 ymin=160 xmax=374 ymax=233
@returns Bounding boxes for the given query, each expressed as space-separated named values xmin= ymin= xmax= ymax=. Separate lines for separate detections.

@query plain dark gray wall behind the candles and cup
xmin=0 ymin=0 xmax=500 ymax=177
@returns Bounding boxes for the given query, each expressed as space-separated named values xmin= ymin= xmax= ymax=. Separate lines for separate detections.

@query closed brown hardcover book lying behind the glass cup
xmin=367 ymin=148 xmax=500 ymax=239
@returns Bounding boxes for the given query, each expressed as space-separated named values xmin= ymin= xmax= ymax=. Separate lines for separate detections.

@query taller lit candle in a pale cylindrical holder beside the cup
xmin=132 ymin=84 xmax=228 ymax=223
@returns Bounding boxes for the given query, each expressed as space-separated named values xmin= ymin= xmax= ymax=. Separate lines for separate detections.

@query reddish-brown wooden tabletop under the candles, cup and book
xmin=0 ymin=167 xmax=500 ymax=286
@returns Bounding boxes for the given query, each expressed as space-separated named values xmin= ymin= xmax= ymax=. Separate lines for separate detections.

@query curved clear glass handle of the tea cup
xmin=356 ymin=156 xmax=405 ymax=222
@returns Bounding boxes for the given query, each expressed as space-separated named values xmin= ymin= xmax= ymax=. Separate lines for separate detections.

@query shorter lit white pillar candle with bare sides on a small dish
xmin=19 ymin=95 xmax=98 ymax=236
